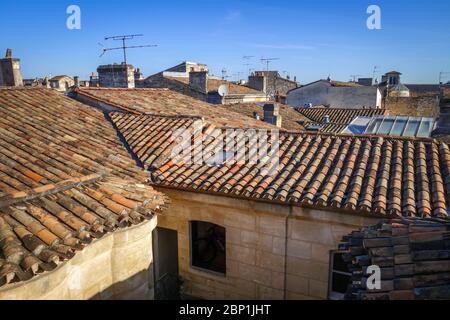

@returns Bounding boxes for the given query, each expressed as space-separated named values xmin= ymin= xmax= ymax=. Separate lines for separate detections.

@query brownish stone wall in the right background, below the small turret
xmin=385 ymin=96 xmax=439 ymax=118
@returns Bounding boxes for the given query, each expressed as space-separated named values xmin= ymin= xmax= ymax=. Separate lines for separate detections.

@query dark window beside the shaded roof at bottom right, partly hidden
xmin=328 ymin=251 xmax=352 ymax=300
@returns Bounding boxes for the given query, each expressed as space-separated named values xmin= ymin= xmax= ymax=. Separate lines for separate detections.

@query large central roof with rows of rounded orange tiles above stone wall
xmin=112 ymin=113 xmax=450 ymax=217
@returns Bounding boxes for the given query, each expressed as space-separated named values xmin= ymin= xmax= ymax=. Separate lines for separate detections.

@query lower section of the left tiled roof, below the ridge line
xmin=0 ymin=175 xmax=167 ymax=286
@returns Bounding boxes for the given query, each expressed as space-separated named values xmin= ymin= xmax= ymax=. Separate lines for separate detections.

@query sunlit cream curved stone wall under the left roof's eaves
xmin=0 ymin=217 xmax=157 ymax=300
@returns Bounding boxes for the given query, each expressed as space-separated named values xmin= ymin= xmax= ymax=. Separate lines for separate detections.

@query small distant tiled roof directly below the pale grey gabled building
xmin=296 ymin=108 xmax=388 ymax=125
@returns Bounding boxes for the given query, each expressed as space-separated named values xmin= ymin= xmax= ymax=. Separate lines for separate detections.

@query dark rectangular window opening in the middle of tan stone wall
xmin=191 ymin=221 xmax=227 ymax=274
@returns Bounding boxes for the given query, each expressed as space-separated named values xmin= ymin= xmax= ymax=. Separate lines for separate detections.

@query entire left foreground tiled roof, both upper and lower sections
xmin=0 ymin=88 xmax=169 ymax=285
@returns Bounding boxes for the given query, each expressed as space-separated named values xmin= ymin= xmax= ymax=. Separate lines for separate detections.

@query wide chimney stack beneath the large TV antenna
xmin=97 ymin=64 xmax=135 ymax=88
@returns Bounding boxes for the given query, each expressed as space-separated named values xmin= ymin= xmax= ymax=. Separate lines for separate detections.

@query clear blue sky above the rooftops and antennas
xmin=0 ymin=0 xmax=450 ymax=83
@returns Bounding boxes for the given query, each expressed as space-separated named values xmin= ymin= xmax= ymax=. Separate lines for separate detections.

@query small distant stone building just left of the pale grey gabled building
xmin=247 ymin=71 xmax=298 ymax=97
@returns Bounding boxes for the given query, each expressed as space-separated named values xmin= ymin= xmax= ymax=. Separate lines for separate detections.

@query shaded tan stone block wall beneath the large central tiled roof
xmin=158 ymin=188 xmax=377 ymax=300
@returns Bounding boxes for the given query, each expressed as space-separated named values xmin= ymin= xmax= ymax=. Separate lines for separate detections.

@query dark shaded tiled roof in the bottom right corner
xmin=340 ymin=219 xmax=450 ymax=300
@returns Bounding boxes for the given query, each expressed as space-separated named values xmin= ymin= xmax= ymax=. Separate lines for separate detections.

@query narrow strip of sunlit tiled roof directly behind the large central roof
xmin=78 ymin=88 xmax=274 ymax=129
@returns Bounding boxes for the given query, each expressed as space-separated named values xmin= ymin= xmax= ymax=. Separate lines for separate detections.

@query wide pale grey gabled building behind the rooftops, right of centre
xmin=287 ymin=80 xmax=382 ymax=109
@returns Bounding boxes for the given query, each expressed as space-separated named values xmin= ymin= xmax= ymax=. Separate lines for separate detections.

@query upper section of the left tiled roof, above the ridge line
xmin=0 ymin=88 xmax=145 ymax=196
